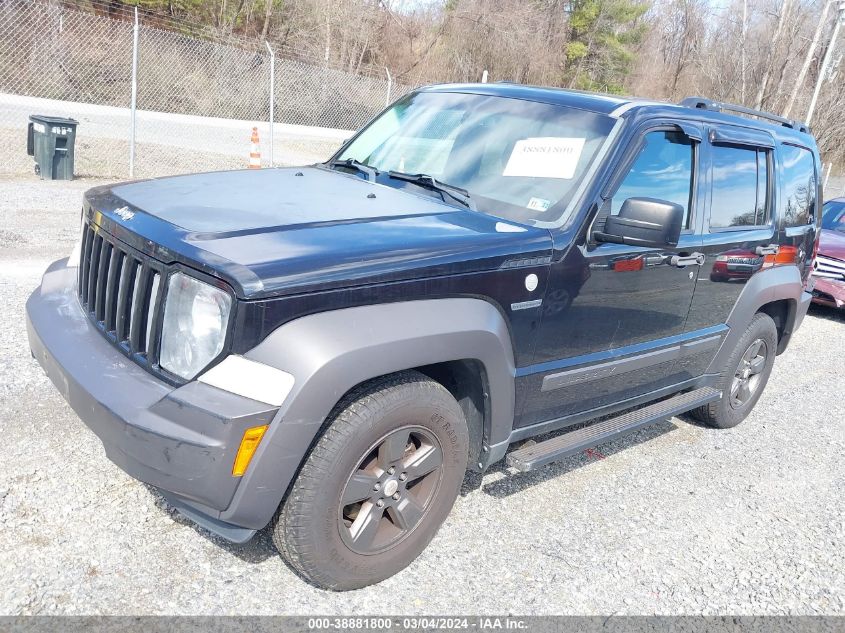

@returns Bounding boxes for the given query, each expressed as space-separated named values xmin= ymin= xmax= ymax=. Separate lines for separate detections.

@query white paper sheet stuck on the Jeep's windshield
xmin=502 ymin=136 xmax=586 ymax=179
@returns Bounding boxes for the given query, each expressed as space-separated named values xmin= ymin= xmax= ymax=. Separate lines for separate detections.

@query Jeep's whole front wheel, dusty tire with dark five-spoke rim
xmin=273 ymin=371 xmax=469 ymax=591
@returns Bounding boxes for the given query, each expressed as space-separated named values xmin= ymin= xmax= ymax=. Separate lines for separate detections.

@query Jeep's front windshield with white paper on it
xmin=335 ymin=92 xmax=615 ymax=222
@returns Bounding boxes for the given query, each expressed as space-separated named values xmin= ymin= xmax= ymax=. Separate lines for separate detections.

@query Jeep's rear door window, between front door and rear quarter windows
xmin=710 ymin=145 xmax=769 ymax=229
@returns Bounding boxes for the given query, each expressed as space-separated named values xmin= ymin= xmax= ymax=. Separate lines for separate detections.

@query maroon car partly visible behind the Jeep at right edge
xmin=813 ymin=198 xmax=845 ymax=308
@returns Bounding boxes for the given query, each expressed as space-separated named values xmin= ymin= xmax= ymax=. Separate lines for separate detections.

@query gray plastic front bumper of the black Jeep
xmin=26 ymin=260 xmax=278 ymax=542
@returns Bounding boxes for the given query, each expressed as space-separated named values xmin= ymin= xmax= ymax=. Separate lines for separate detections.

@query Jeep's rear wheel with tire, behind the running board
xmin=692 ymin=312 xmax=778 ymax=429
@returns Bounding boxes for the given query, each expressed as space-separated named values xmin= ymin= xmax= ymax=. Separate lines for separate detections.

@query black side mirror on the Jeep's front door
xmin=593 ymin=198 xmax=684 ymax=248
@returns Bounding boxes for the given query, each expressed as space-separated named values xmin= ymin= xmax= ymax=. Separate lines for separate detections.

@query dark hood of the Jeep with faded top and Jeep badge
xmin=84 ymin=167 xmax=552 ymax=298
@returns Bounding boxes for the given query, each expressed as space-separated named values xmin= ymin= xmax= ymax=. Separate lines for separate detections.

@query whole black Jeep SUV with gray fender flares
xmin=27 ymin=84 xmax=821 ymax=590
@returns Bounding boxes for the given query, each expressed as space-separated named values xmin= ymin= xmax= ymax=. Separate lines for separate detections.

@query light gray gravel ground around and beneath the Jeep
xmin=0 ymin=176 xmax=845 ymax=615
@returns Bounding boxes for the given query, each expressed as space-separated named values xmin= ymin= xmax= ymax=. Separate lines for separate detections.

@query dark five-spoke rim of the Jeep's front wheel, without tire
xmin=338 ymin=426 xmax=443 ymax=554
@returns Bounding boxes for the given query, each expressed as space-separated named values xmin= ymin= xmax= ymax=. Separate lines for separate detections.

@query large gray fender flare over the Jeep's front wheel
xmin=220 ymin=298 xmax=515 ymax=529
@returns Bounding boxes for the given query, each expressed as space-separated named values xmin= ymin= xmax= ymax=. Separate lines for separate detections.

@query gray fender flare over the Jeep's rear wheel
xmin=706 ymin=266 xmax=811 ymax=374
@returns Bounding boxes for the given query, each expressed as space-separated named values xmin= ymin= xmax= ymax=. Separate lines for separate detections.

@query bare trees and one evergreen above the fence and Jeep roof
xmin=68 ymin=0 xmax=845 ymax=164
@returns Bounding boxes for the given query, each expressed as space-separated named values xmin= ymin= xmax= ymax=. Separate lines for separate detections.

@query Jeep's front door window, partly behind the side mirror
xmin=610 ymin=131 xmax=694 ymax=228
